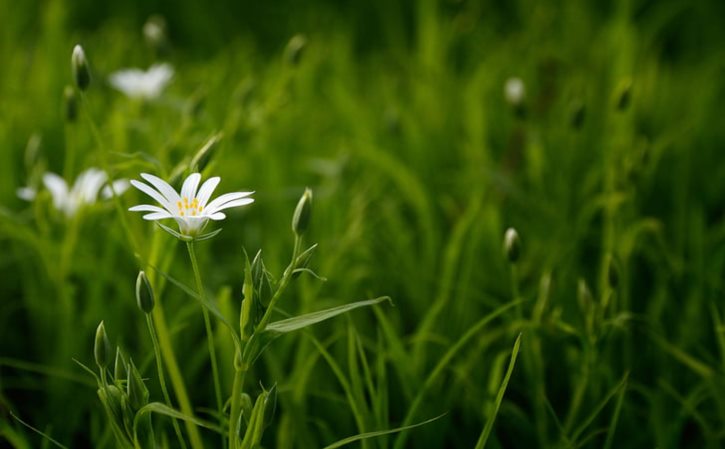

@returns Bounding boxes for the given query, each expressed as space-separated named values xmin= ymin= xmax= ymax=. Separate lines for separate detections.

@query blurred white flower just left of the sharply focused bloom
xmin=17 ymin=168 xmax=128 ymax=218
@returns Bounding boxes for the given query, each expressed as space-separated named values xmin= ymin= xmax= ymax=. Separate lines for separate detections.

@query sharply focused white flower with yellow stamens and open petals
xmin=129 ymin=173 xmax=254 ymax=237
